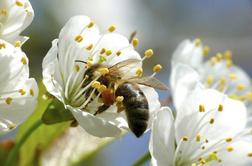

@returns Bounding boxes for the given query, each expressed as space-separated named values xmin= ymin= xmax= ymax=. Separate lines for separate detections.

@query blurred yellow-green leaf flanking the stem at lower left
xmin=16 ymin=83 xmax=70 ymax=166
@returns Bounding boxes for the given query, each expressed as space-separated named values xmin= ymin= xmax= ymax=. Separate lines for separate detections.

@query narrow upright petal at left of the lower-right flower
xmin=149 ymin=107 xmax=175 ymax=166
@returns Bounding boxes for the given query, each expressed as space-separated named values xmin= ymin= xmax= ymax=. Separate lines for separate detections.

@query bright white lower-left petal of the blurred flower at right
xmin=170 ymin=63 xmax=200 ymax=111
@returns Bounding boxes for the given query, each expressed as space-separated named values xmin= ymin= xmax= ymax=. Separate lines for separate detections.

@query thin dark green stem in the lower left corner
xmin=5 ymin=119 xmax=43 ymax=166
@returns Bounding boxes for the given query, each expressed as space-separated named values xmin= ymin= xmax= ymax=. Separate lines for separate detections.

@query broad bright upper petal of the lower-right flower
xmin=175 ymin=87 xmax=247 ymax=142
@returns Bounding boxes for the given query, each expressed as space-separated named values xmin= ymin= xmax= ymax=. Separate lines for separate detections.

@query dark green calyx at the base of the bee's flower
xmin=42 ymin=99 xmax=74 ymax=125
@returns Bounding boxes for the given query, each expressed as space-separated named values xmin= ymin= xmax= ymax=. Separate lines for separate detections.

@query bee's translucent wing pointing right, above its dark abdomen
xmin=127 ymin=77 xmax=168 ymax=90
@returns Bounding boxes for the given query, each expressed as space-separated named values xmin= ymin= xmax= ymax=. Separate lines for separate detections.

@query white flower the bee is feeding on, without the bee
xmin=43 ymin=16 xmax=160 ymax=137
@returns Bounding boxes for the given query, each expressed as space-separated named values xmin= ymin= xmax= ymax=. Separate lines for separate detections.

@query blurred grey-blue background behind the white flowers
xmin=1 ymin=0 xmax=252 ymax=166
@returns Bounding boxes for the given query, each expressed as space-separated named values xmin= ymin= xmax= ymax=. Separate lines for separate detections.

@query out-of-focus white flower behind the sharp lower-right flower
xmin=170 ymin=39 xmax=252 ymax=123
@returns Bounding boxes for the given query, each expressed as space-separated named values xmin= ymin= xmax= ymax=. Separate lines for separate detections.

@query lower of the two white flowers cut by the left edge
xmin=0 ymin=39 xmax=38 ymax=132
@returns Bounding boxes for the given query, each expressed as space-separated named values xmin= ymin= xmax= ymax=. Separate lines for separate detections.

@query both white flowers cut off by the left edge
xmin=0 ymin=0 xmax=38 ymax=133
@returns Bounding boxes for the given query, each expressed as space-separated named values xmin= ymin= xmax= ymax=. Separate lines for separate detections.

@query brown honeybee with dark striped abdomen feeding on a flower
xmin=76 ymin=59 xmax=168 ymax=137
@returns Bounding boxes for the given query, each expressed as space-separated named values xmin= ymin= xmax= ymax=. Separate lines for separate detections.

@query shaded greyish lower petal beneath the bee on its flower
xmin=68 ymin=107 xmax=121 ymax=137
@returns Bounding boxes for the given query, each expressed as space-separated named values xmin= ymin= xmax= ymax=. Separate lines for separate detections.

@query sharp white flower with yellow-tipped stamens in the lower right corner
xmin=149 ymin=84 xmax=252 ymax=166
